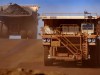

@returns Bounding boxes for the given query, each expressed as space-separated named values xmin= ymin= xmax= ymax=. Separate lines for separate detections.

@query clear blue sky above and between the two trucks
xmin=0 ymin=0 xmax=100 ymax=38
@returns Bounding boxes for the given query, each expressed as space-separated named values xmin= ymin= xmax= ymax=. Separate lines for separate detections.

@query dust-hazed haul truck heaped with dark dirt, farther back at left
xmin=0 ymin=3 xmax=39 ymax=39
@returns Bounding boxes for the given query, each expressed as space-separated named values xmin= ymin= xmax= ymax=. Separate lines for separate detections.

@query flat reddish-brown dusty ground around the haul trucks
xmin=0 ymin=40 xmax=100 ymax=75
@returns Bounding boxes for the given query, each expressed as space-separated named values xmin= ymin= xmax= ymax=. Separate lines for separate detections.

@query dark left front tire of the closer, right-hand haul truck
xmin=44 ymin=46 xmax=53 ymax=66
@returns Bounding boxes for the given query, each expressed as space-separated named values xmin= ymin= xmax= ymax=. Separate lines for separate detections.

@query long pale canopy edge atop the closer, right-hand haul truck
xmin=40 ymin=13 xmax=98 ymax=19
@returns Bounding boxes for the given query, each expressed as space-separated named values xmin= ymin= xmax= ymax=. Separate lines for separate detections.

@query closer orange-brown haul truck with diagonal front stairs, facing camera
xmin=41 ymin=12 xmax=100 ymax=65
